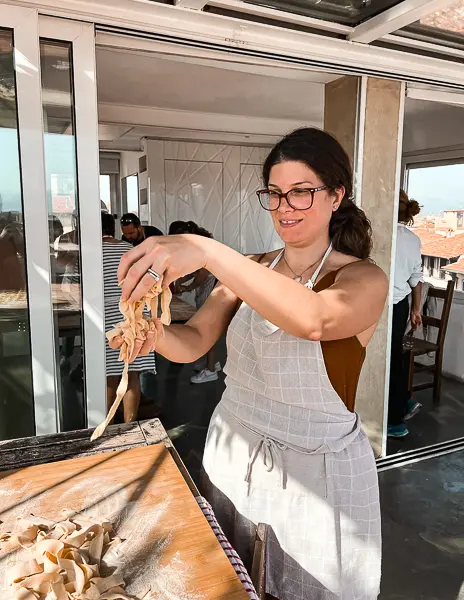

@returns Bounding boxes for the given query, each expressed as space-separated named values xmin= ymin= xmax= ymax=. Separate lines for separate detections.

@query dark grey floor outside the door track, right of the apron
xmin=379 ymin=451 xmax=464 ymax=600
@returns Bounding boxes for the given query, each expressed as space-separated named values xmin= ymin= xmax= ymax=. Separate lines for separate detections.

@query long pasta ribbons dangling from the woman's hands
xmin=90 ymin=281 xmax=172 ymax=441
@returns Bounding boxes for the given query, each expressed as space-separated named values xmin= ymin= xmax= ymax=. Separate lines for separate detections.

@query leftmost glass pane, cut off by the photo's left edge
xmin=0 ymin=30 xmax=35 ymax=440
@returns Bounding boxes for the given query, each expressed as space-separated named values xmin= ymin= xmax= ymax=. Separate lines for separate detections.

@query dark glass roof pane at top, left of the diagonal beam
xmin=237 ymin=0 xmax=401 ymax=25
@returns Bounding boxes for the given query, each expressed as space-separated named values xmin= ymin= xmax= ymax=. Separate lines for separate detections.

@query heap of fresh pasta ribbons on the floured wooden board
xmin=0 ymin=513 xmax=155 ymax=600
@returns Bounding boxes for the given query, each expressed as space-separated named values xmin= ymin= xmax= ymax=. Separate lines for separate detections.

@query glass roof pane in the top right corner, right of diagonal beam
xmin=397 ymin=0 xmax=464 ymax=48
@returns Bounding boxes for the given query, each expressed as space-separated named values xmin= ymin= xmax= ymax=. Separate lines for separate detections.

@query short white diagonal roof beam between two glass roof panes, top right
xmin=348 ymin=0 xmax=452 ymax=44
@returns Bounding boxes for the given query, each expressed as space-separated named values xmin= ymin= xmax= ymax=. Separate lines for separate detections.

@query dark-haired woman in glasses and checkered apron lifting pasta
xmin=119 ymin=128 xmax=388 ymax=600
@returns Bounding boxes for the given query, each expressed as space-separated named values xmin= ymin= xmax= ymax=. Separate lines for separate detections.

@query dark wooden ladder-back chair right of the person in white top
xmin=403 ymin=281 xmax=454 ymax=404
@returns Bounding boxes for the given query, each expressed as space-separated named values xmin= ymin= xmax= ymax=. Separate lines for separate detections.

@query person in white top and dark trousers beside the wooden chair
xmin=388 ymin=190 xmax=423 ymax=438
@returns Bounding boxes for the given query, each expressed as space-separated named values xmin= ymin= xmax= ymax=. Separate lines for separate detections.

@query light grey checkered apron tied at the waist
xmin=203 ymin=249 xmax=381 ymax=600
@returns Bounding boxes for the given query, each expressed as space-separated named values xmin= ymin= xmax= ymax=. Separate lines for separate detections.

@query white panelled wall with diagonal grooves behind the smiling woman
xmin=146 ymin=140 xmax=282 ymax=254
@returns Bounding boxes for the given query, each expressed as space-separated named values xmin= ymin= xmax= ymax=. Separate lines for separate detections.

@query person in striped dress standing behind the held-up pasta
xmin=101 ymin=212 xmax=155 ymax=423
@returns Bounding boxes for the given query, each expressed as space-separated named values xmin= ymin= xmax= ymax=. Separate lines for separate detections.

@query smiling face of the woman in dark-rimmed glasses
xmin=268 ymin=161 xmax=345 ymax=246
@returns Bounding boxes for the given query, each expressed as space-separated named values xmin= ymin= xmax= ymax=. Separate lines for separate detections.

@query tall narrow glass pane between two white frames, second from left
xmin=40 ymin=40 xmax=86 ymax=431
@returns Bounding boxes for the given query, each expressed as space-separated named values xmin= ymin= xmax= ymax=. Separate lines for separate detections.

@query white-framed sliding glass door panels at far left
xmin=0 ymin=5 xmax=105 ymax=440
